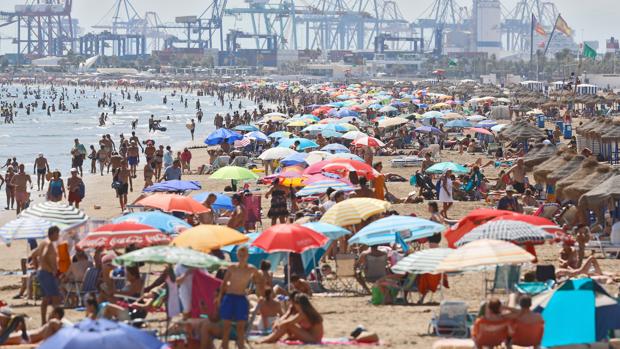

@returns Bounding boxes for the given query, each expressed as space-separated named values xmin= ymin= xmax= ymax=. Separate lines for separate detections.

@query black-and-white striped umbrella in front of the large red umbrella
xmin=456 ymin=220 xmax=554 ymax=247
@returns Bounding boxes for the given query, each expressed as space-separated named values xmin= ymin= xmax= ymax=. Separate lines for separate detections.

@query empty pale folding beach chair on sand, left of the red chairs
xmin=428 ymin=300 xmax=469 ymax=338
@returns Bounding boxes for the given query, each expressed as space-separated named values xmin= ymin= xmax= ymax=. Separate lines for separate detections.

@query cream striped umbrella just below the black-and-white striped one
xmin=437 ymin=239 xmax=535 ymax=273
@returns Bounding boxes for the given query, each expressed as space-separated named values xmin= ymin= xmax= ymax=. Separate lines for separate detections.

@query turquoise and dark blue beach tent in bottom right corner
xmin=532 ymin=278 xmax=620 ymax=348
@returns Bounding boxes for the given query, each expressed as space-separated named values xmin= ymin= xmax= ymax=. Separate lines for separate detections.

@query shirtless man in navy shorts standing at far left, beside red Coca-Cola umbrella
xmin=31 ymin=226 xmax=60 ymax=325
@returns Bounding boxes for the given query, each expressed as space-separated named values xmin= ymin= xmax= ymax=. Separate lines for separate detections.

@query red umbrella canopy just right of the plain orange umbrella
xmin=252 ymin=224 xmax=329 ymax=253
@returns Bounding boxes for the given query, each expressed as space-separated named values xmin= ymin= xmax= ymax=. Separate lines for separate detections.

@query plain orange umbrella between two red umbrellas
xmin=170 ymin=224 xmax=248 ymax=252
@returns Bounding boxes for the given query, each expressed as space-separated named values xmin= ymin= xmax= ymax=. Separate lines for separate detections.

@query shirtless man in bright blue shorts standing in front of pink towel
xmin=215 ymin=246 xmax=265 ymax=349
